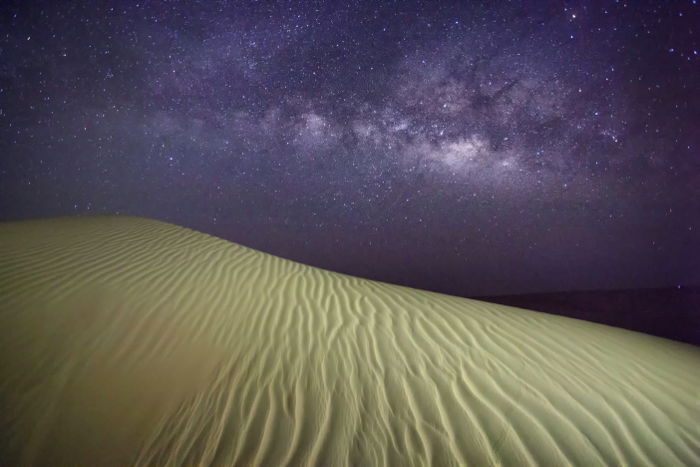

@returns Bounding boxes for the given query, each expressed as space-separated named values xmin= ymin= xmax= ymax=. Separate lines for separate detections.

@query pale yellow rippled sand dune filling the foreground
xmin=0 ymin=217 xmax=700 ymax=466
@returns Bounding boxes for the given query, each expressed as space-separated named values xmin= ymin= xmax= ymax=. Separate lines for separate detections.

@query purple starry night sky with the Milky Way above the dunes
xmin=0 ymin=0 xmax=700 ymax=296
